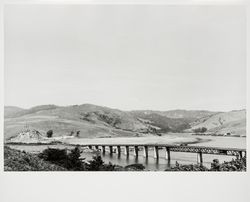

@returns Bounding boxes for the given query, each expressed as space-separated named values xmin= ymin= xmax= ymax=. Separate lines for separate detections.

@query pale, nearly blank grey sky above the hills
xmin=4 ymin=4 xmax=246 ymax=111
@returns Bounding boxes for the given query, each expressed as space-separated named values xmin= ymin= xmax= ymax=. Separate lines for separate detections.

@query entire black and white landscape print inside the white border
xmin=2 ymin=3 xmax=247 ymax=172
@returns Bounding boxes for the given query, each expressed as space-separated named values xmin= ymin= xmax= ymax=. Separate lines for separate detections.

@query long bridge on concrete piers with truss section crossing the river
xmin=75 ymin=144 xmax=246 ymax=164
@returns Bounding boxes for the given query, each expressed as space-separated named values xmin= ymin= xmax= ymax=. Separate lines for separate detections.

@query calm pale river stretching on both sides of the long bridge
xmin=7 ymin=133 xmax=246 ymax=171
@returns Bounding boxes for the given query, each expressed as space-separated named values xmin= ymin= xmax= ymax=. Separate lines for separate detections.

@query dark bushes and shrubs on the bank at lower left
xmin=4 ymin=146 xmax=145 ymax=171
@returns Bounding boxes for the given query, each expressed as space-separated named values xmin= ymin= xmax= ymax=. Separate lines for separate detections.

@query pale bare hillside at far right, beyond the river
xmin=188 ymin=110 xmax=246 ymax=136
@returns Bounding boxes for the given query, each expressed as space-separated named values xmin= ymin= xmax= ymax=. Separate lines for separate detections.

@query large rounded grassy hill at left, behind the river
xmin=4 ymin=104 xmax=148 ymax=139
